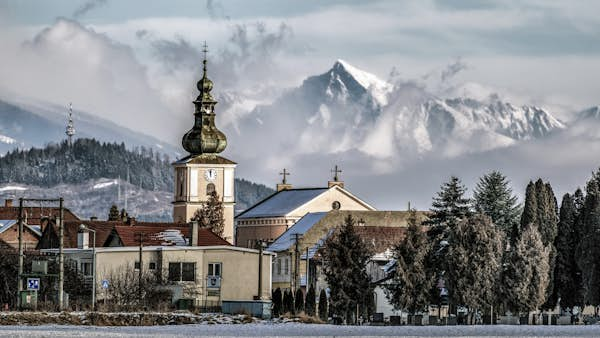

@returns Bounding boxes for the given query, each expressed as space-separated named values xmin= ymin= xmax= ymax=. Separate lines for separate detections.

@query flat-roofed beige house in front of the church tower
xmin=42 ymin=245 xmax=274 ymax=306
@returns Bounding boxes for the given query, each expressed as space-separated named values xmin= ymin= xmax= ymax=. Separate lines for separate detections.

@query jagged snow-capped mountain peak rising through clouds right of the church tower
xmin=229 ymin=60 xmax=565 ymax=164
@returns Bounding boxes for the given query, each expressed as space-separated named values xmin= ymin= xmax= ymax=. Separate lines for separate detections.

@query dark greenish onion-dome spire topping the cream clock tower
xmin=182 ymin=42 xmax=227 ymax=156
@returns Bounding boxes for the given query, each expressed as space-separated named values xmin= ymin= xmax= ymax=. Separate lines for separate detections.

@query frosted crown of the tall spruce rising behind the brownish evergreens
xmin=473 ymin=171 xmax=521 ymax=238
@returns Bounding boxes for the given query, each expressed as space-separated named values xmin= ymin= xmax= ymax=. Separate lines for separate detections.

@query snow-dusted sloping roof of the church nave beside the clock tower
xmin=236 ymin=188 xmax=328 ymax=219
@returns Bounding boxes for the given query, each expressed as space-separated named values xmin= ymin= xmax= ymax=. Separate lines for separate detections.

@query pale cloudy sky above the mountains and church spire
xmin=0 ymin=0 xmax=600 ymax=209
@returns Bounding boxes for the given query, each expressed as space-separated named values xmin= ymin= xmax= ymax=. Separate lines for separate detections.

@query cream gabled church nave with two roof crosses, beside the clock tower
xmin=235 ymin=181 xmax=375 ymax=248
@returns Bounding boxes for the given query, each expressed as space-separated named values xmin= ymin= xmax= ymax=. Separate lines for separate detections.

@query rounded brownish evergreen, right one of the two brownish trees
xmin=503 ymin=225 xmax=550 ymax=312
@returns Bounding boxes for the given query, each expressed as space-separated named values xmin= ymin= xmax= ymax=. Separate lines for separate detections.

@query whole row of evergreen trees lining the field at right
xmin=322 ymin=170 xmax=600 ymax=323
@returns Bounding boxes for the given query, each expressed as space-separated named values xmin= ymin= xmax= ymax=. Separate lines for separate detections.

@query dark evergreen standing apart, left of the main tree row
xmin=323 ymin=215 xmax=373 ymax=323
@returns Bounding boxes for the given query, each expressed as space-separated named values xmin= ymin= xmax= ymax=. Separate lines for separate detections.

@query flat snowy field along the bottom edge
xmin=0 ymin=323 xmax=600 ymax=338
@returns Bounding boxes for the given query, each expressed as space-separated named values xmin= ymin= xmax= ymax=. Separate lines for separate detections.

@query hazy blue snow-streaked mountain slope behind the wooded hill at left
xmin=0 ymin=99 xmax=178 ymax=157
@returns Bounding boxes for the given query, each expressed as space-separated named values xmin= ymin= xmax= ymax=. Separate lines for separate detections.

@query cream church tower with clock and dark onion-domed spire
xmin=173 ymin=44 xmax=236 ymax=243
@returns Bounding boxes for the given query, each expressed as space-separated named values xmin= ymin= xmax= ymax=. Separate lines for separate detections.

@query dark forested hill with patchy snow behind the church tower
xmin=0 ymin=138 xmax=273 ymax=217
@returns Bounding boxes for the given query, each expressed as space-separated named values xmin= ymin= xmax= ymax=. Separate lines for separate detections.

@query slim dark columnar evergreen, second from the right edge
xmin=552 ymin=194 xmax=583 ymax=309
